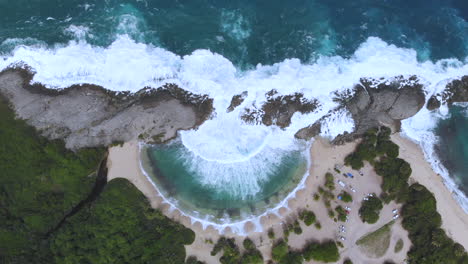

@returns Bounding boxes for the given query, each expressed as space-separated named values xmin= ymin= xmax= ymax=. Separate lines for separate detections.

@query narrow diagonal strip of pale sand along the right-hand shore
xmin=392 ymin=134 xmax=468 ymax=249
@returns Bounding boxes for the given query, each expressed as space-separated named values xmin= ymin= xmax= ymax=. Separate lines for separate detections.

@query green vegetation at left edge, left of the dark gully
xmin=0 ymin=97 xmax=104 ymax=263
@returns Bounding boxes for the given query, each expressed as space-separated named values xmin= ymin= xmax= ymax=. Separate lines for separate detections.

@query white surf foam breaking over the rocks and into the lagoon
xmin=0 ymin=35 xmax=468 ymax=219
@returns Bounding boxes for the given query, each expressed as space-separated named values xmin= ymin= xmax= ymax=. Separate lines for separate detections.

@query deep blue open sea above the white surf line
xmin=0 ymin=0 xmax=468 ymax=65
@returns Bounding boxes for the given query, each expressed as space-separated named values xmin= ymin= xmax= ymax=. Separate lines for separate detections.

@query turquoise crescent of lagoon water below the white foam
xmin=142 ymin=141 xmax=307 ymax=220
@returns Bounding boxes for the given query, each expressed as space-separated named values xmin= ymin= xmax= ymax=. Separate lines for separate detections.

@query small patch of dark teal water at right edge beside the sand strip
xmin=436 ymin=106 xmax=468 ymax=194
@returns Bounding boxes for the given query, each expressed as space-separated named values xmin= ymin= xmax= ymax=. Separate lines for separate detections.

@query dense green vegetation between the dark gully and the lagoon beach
xmin=51 ymin=179 xmax=195 ymax=263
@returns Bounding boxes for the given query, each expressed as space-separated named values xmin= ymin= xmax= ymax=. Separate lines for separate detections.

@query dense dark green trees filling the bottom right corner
xmin=402 ymin=183 xmax=468 ymax=264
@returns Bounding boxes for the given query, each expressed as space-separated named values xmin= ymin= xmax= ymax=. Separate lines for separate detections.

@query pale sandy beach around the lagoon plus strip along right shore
xmin=108 ymin=135 xmax=468 ymax=264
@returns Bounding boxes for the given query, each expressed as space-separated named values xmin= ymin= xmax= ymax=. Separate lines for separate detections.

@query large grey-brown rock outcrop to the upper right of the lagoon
xmin=295 ymin=76 xmax=425 ymax=144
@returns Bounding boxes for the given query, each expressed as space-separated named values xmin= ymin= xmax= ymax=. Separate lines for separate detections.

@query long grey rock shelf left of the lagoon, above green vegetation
xmin=0 ymin=69 xmax=212 ymax=149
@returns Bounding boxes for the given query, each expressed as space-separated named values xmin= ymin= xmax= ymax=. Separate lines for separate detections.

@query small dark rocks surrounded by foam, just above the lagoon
xmin=241 ymin=90 xmax=319 ymax=128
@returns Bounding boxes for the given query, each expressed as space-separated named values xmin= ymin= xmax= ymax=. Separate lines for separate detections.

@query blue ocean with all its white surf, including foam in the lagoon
xmin=0 ymin=0 xmax=468 ymax=221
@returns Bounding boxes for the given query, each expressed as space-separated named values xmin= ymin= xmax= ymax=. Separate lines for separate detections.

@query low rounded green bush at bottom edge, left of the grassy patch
xmin=303 ymin=241 xmax=340 ymax=262
